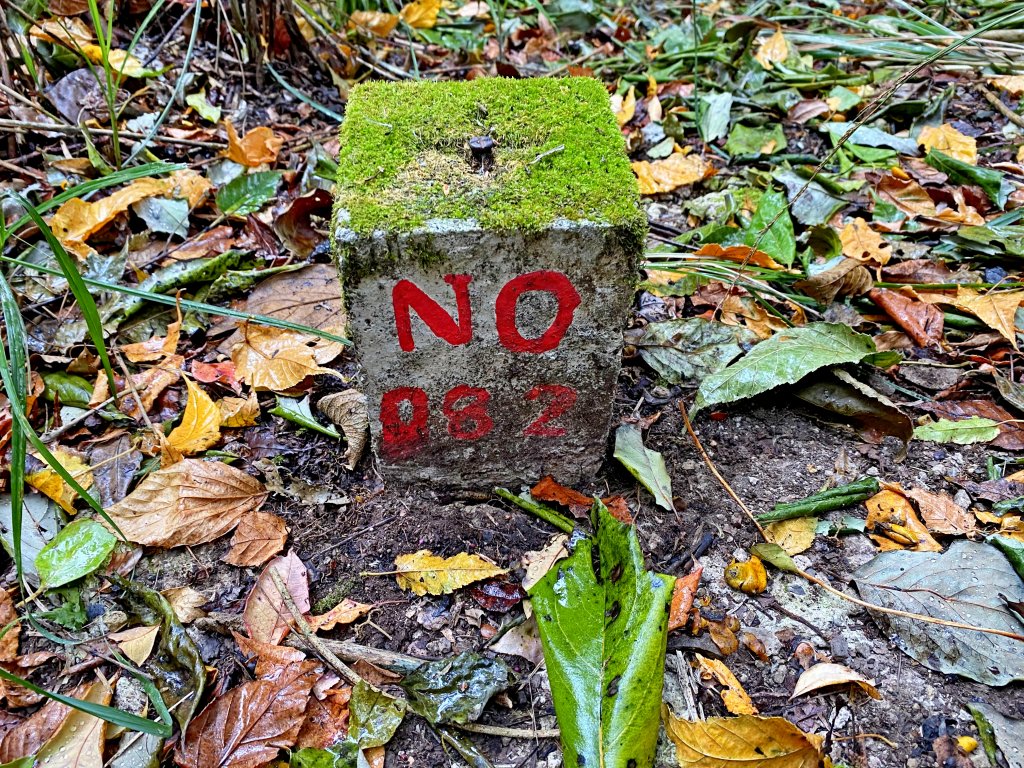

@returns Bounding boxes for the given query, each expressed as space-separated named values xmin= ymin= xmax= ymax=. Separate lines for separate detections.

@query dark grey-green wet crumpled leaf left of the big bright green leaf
xmin=401 ymin=651 xmax=512 ymax=725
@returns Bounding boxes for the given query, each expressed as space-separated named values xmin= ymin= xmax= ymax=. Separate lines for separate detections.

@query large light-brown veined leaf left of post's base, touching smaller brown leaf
xmin=108 ymin=459 xmax=267 ymax=547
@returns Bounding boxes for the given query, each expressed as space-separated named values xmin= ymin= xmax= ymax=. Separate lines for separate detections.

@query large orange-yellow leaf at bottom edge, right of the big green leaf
xmin=663 ymin=707 xmax=822 ymax=768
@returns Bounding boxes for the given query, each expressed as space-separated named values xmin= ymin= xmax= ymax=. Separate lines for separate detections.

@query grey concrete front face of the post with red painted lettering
xmin=336 ymin=221 xmax=636 ymax=489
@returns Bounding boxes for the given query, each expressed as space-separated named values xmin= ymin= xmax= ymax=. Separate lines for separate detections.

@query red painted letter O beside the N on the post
xmin=495 ymin=269 xmax=580 ymax=354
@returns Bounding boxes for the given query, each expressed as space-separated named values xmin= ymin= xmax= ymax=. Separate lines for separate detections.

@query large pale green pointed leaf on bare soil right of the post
xmin=693 ymin=323 xmax=876 ymax=414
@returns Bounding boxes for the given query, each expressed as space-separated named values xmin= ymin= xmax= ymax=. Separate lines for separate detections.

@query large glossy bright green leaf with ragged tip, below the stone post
xmin=530 ymin=501 xmax=675 ymax=768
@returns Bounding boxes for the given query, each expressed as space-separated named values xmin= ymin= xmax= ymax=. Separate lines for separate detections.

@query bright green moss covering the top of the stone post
xmin=336 ymin=78 xmax=646 ymax=239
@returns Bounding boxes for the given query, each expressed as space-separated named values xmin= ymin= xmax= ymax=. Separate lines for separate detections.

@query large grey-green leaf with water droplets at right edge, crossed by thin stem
xmin=851 ymin=541 xmax=1024 ymax=685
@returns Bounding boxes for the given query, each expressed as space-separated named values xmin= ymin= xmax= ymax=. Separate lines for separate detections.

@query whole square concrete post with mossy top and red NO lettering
xmin=334 ymin=78 xmax=646 ymax=489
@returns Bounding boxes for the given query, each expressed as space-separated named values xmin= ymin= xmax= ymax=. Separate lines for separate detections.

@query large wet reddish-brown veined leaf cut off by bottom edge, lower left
xmin=174 ymin=662 xmax=319 ymax=768
